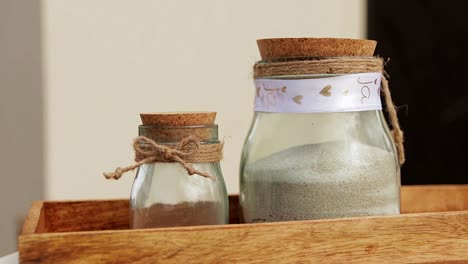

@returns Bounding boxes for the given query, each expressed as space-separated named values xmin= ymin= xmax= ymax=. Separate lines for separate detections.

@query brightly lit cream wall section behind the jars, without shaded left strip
xmin=42 ymin=0 xmax=366 ymax=199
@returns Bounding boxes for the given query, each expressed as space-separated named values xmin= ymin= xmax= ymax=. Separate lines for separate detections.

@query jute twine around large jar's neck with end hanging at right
xmin=254 ymin=57 xmax=405 ymax=165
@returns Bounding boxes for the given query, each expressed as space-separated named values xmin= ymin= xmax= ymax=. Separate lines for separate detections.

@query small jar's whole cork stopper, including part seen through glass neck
xmin=139 ymin=112 xmax=218 ymax=142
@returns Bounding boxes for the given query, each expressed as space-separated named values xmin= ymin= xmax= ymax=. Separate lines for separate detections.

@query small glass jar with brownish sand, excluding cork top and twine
xmin=130 ymin=124 xmax=229 ymax=228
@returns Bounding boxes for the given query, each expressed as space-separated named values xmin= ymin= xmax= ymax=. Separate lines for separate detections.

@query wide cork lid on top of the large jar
xmin=257 ymin=38 xmax=377 ymax=60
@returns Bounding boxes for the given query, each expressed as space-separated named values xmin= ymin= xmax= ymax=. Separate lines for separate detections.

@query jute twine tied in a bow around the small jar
xmin=104 ymin=136 xmax=223 ymax=180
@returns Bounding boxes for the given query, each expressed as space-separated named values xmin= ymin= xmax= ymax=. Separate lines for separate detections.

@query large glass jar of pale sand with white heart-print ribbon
xmin=240 ymin=39 xmax=400 ymax=222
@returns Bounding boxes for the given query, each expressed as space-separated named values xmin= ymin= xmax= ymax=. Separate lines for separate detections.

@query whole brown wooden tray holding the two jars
xmin=19 ymin=185 xmax=468 ymax=263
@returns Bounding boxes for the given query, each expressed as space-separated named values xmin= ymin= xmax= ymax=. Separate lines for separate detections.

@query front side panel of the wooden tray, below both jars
xmin=19 ymin=212 xmax=468 ymax=263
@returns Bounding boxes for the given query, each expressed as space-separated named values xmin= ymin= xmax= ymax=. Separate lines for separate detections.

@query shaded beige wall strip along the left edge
xmin=0 ymin=0 xmax=44 ymax=256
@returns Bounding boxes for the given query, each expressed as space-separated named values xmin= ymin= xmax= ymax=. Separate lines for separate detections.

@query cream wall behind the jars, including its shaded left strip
xmin=0 ymin=0 xmax=366 ymax=256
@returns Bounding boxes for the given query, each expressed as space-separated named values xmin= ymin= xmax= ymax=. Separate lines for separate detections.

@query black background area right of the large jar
xmin=368 ymin=0 xmax=468 ymax=184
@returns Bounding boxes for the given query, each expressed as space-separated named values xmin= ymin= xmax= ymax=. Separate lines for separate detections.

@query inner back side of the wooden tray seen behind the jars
xmin=23 ymin=185 xmax=468 ymax=234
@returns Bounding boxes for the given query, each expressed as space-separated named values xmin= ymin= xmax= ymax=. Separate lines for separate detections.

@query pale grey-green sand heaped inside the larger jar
xmin=243 ymin=141 xmax=400 ymax=222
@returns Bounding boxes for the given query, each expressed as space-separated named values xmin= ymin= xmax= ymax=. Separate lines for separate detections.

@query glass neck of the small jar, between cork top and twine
xmin=138 ymin=124 xmax=219 ymax=144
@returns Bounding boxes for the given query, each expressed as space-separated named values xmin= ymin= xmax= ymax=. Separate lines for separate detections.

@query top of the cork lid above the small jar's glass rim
xmin=140 ymin=112 xmax=216 ymax=126
